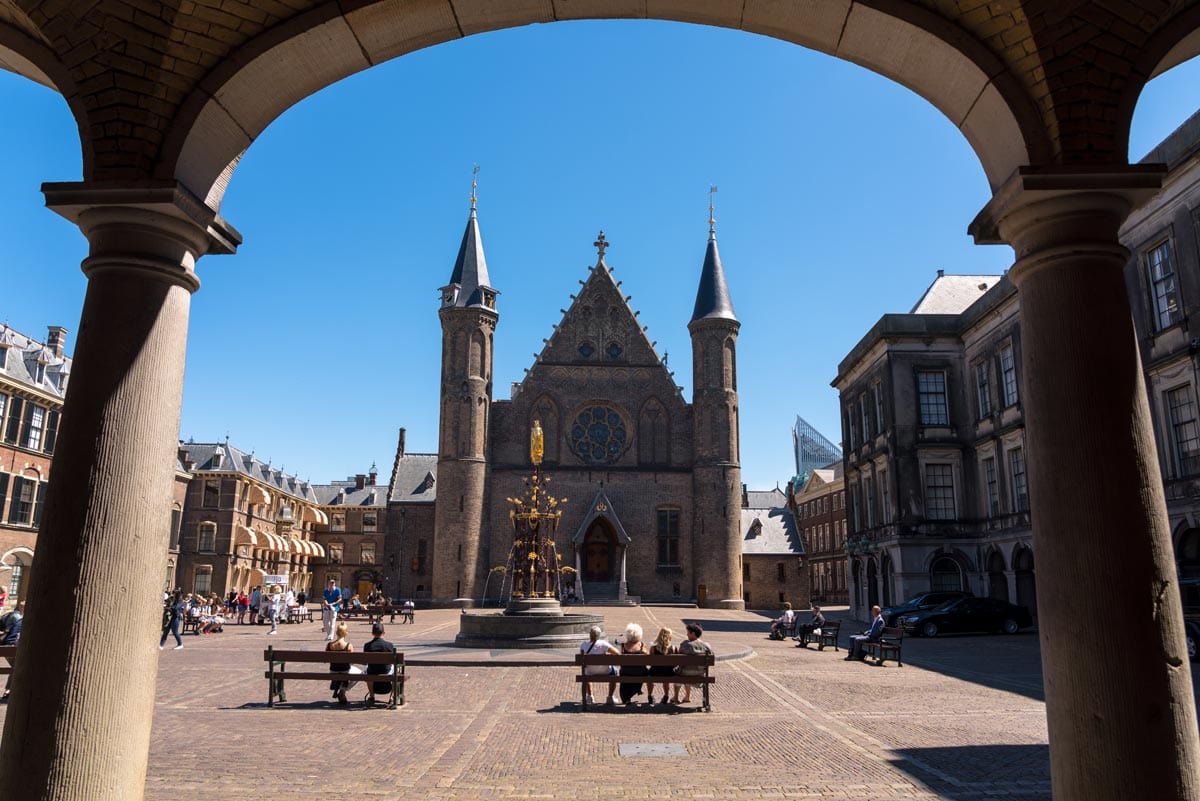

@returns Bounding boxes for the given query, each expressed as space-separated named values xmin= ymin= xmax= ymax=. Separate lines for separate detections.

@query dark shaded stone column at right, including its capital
xmin=972 ymin=167 xmax=1200 ymax=801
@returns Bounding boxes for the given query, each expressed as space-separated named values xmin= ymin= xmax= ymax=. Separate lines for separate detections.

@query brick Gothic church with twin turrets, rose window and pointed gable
xmin=388 ymin=203 xmax=743 ymax=608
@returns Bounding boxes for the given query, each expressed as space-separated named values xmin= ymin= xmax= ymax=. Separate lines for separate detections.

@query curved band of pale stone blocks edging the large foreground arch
xmin=162 ymin=0 xmax=1050 ymax=209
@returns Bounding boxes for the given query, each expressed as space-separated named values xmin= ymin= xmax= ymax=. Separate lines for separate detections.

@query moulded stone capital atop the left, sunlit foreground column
xmin=42 ymin=181 xmax=241 ymax=291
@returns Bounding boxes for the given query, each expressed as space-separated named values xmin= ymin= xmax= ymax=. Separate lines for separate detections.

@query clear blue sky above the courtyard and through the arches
xmin=0 ymin=22 xmax=1200 ymax=488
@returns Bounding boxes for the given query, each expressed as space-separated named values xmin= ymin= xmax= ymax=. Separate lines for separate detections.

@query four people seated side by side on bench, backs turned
xmin=580 ymin=624 xmax=713 ymax=706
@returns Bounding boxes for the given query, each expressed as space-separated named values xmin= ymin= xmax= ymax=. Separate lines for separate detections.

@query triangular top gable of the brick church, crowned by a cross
xmin=522 ymin=231 xmax=674 ymax=386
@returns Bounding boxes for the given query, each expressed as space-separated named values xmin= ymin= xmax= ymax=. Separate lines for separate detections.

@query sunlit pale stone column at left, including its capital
xmin=0 ymin=185 xmax=238 ymax=801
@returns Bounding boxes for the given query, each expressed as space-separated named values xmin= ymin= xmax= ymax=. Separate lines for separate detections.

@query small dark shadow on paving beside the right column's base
xmin=889 ymin=743 xmax=1050 ymax=801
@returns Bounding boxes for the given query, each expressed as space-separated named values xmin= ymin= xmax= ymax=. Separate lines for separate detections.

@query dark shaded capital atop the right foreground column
xmin=967 ymin=164 xmax=1166 ymax=285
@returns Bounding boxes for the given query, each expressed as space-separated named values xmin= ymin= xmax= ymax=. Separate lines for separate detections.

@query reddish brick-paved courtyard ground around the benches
xmin=0 ymin=608 xmax=1050 ymax=801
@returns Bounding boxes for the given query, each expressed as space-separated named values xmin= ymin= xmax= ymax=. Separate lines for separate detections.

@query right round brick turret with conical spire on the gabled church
xmin=688 ymin=194 xmax=745 ymax=609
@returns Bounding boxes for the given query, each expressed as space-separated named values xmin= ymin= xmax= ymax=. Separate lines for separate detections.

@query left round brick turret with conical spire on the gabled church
xmin=434 ymin=173 xmax=499 ymax=601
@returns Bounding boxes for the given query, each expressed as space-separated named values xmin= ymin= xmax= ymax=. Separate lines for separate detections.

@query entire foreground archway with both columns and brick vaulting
xmin=0 ymin=6 xmax=1200 ymax=799
